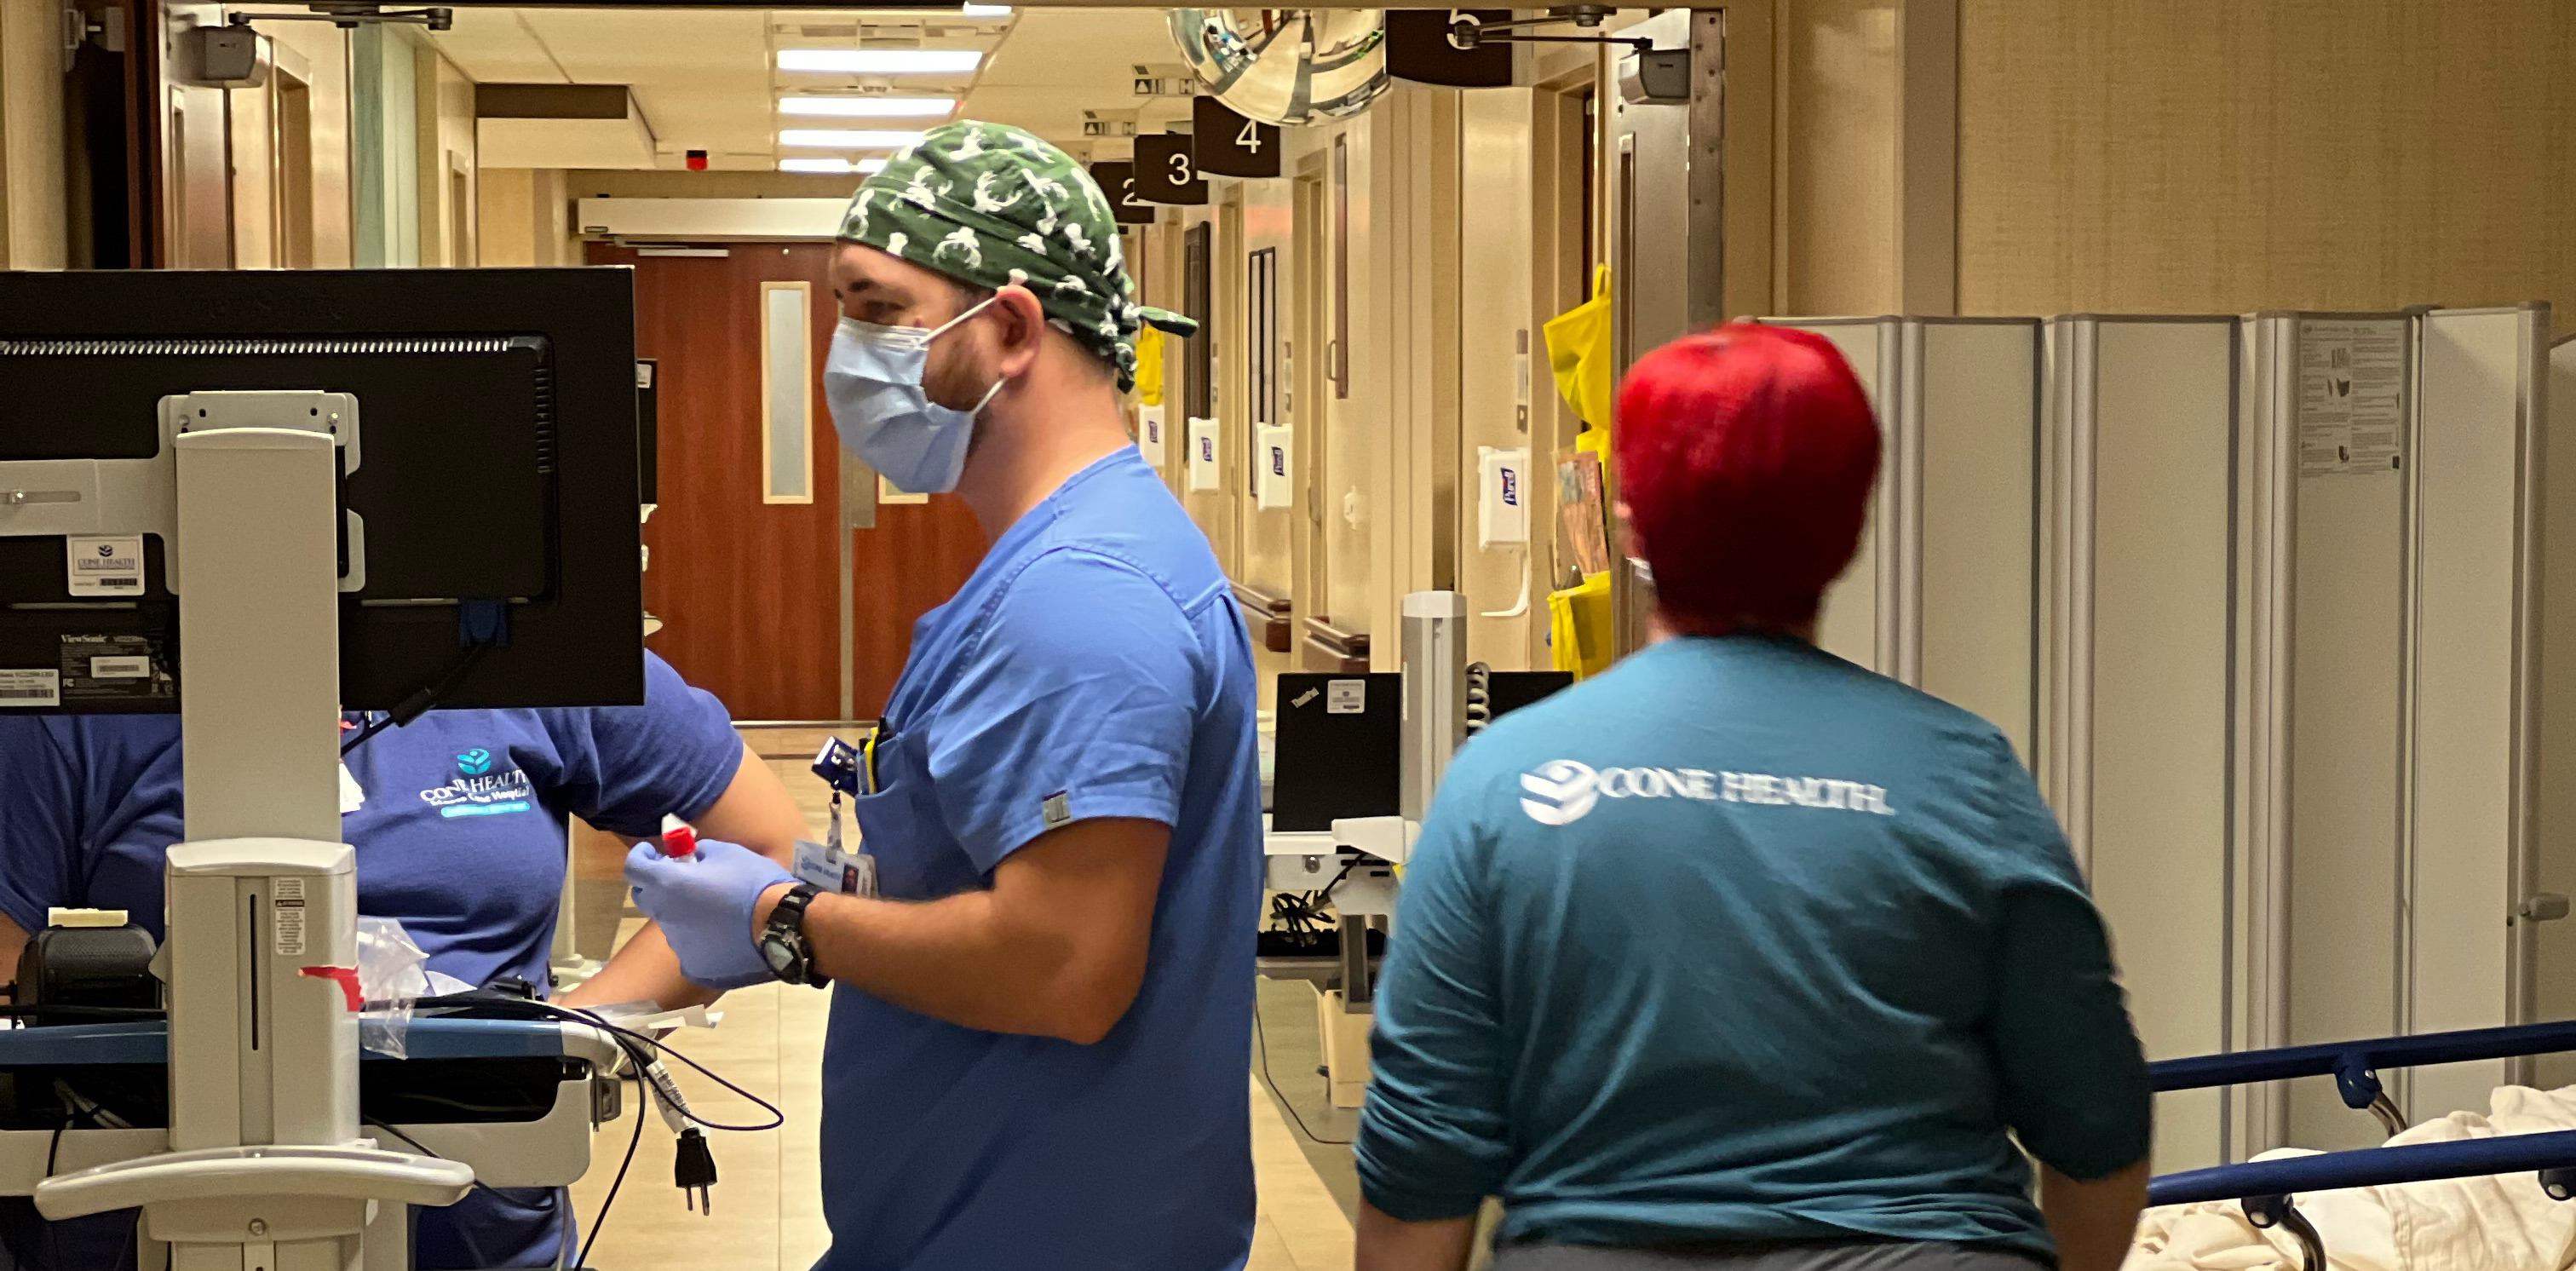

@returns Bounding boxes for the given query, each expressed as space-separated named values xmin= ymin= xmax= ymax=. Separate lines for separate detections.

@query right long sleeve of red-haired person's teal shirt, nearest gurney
xmin=1992 ymin=732 xmax=2153 ymax=1181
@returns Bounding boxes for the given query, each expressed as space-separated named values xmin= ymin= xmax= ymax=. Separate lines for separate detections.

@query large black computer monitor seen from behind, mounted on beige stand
xmin=0 ymin=268 xmax=644 ymax=714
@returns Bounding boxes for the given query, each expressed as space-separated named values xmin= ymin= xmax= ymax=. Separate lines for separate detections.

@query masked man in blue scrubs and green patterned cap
xmin=629 ymin=121 xmax=1262 ymax=1271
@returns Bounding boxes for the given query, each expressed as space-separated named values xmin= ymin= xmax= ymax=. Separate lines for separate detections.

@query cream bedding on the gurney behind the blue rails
xmin=2123 ymin=1085 xmax=2576 ymax=1271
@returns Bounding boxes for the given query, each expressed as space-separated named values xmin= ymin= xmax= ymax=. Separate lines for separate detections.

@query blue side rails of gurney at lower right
xmin=2146 ymin=1021 xmax=2576 ymax=1271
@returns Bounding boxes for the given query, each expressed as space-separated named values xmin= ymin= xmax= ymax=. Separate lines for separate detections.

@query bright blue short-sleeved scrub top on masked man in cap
xmin=819 ymin=449 xmax=1262 ymax=1271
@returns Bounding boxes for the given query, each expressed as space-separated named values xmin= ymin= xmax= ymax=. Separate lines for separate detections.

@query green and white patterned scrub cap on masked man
xmin=840 ymin=118 xmax=1198 ymax=392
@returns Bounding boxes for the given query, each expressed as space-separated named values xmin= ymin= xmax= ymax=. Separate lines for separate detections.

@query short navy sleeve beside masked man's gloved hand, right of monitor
xmin=546 ymin=653 xmax=742 ymax=838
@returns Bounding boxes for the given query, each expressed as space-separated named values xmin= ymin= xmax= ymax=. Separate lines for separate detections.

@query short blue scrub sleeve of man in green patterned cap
xmin=932 ymin=549 xmax=1200 ymax=871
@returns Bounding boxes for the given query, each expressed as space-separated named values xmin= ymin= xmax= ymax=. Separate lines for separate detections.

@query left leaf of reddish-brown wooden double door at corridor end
xmin=589 ymin=242 xmax=842 ymax=722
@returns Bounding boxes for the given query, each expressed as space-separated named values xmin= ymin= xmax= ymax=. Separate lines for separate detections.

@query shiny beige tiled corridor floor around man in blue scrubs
xmin=572 ymin=729 xmax=1358 ymax=1271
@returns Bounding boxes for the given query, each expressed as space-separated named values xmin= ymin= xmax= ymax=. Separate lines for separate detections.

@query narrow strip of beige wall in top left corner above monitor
xmin=0 ymin=0 xmax=70 ymax=268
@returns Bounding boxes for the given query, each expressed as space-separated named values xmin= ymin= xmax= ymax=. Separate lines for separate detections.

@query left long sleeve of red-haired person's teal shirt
xmin=1353 ymin=768 xmax=1515 ymax=1222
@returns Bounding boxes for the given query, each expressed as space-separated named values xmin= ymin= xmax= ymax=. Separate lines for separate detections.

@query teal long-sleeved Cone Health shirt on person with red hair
xmin=1358 ymin=637 xmax=2151 ymax=1256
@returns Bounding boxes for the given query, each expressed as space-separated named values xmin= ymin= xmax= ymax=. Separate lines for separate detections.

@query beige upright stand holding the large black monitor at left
xmin=36 ymin=392 xmax=474 ymax=1271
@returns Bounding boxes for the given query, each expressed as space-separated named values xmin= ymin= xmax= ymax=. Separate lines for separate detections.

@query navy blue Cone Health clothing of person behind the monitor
xmin=0 ymin=655 xmax=742 ymax=1271
